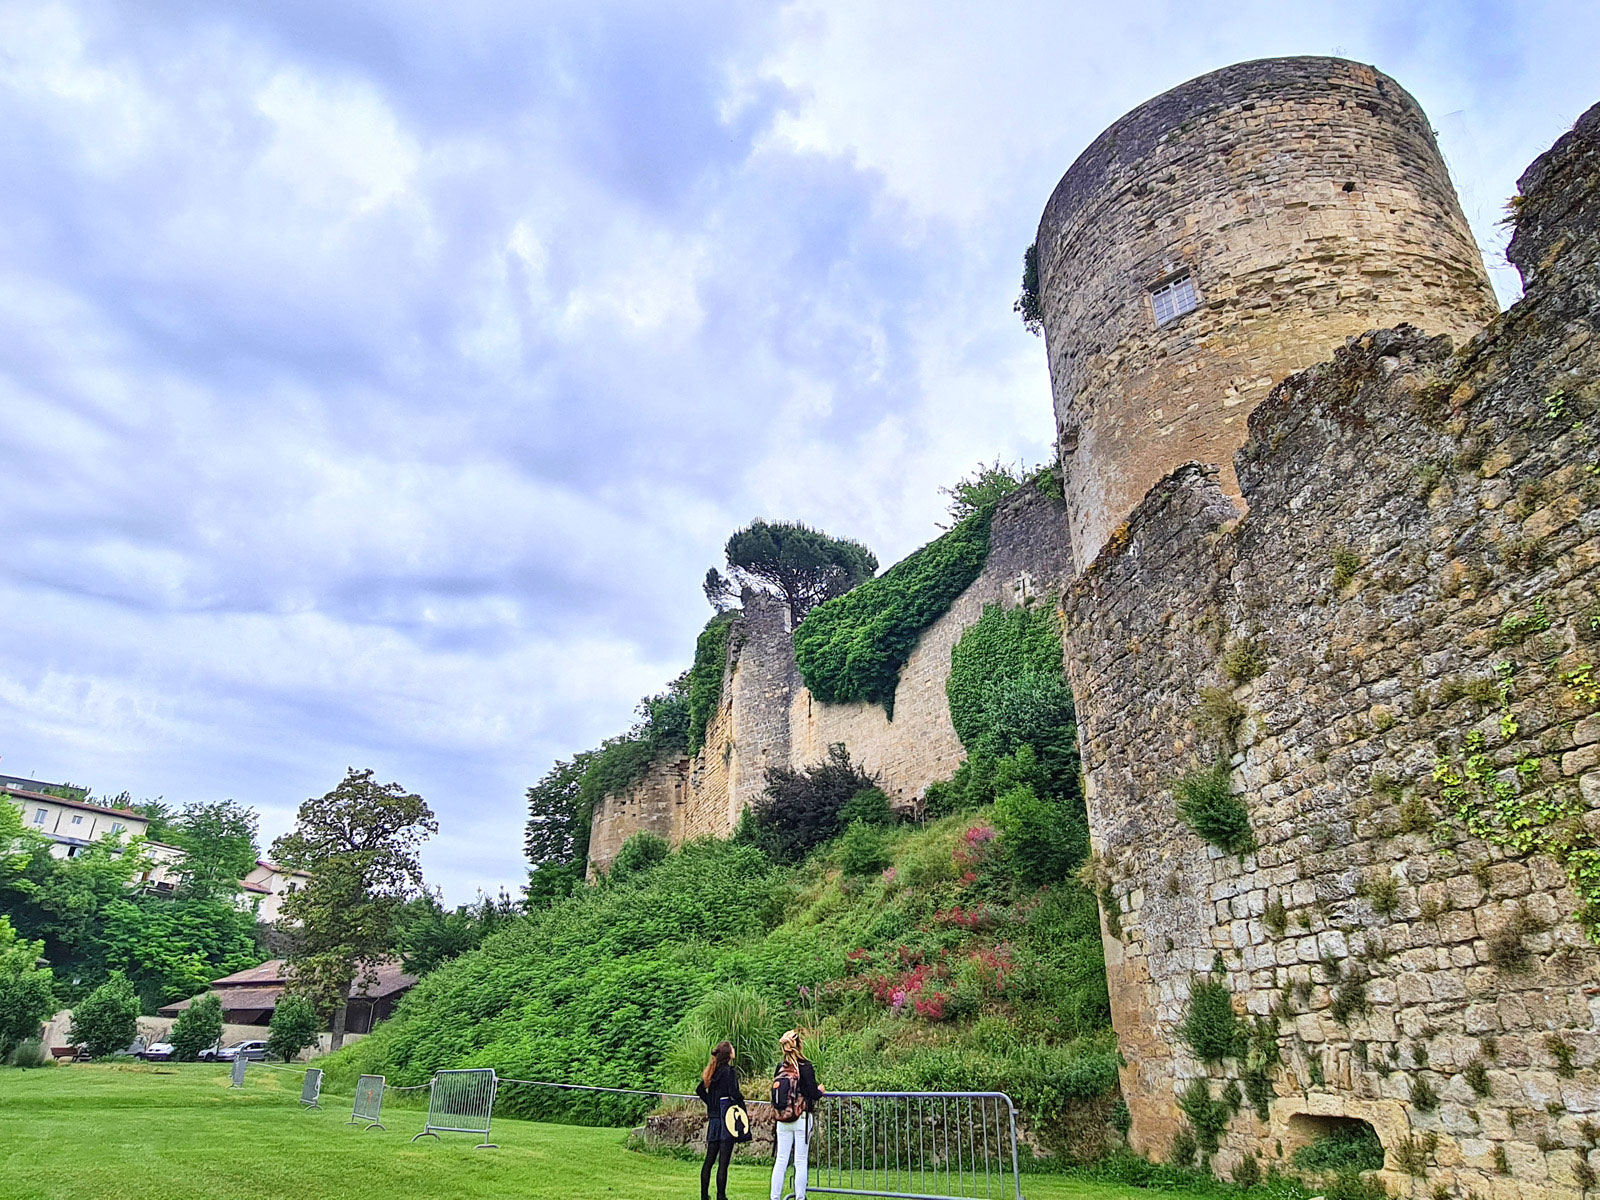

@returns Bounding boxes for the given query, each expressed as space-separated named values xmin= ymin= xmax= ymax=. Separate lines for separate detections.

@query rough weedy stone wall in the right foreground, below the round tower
xmin=1064 ymin=107 xmax=1600 ymax=1200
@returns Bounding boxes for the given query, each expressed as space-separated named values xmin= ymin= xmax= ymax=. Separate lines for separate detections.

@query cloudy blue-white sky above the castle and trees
xmin=0 ymin=0 xmax=1600 ymax=901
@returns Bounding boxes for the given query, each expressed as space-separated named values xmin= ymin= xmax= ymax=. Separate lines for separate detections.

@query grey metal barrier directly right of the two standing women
xmin=806 ymin=1091 xmax=1022 ymax=1200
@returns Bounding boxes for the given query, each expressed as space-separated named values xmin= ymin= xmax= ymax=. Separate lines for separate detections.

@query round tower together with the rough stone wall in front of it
xmin=1038 ymin=59 xmax=1600 ymax=1200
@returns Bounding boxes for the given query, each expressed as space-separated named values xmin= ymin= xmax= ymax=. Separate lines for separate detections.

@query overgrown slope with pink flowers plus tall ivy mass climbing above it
xmin=326 ymin=605 xmax=1118 ymax=1155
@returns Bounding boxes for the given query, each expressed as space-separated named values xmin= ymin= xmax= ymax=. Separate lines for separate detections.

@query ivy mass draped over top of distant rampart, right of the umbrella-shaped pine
xmin=794 ymin=507 xmax=994 ymax=717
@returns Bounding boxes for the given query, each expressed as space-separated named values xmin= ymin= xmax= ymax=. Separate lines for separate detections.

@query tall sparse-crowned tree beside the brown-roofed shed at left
xmin=272 ymin=766 xmax=438 ymax=1050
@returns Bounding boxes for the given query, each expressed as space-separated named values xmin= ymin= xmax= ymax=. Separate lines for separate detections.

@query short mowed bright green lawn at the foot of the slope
xmin=0 ymin=1064 xmax=1171 ymax=1200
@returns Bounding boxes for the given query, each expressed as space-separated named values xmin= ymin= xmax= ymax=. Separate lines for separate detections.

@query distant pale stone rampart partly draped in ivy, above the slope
xmin=589 ymin=485 xmax=1072 ymax=874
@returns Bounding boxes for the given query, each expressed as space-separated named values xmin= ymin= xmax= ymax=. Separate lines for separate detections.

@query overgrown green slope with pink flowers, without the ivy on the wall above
xmin=325 ymin=810 xmax=1115 ymax=1158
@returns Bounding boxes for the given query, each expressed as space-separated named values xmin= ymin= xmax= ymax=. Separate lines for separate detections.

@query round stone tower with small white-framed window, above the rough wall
xmin=1038 ymin=58 xmax=1499 ymax=571
